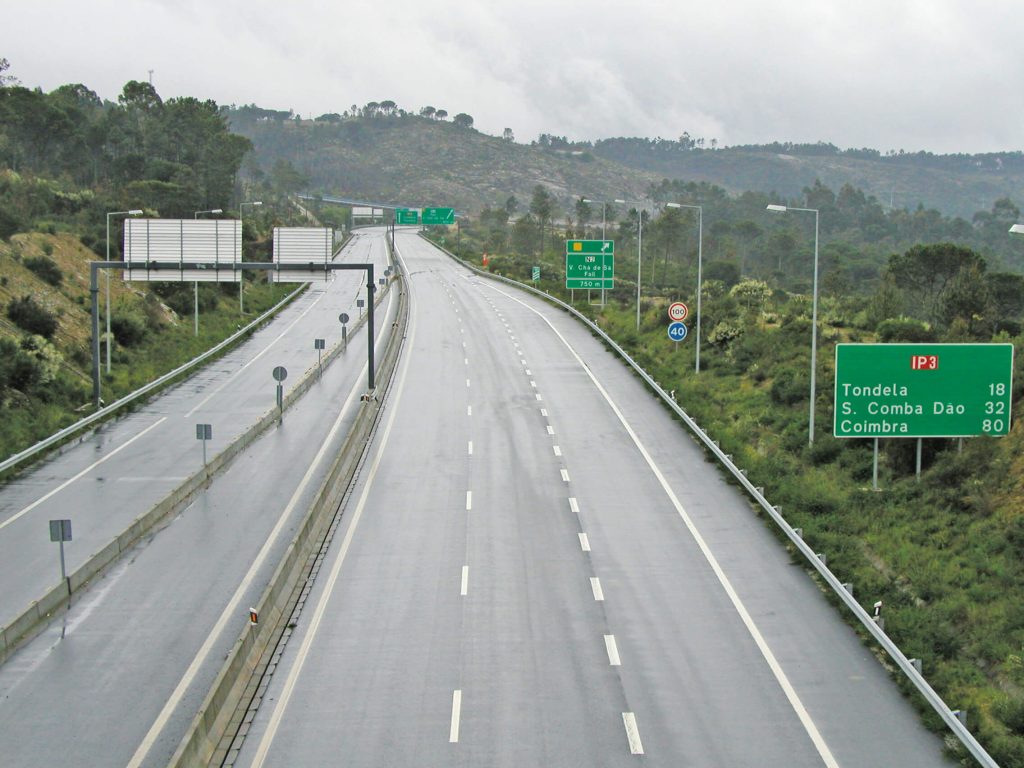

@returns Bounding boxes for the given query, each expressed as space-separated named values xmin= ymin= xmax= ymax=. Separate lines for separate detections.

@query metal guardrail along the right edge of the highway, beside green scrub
xmin=430 ymin=236 xmax=999 ymax=768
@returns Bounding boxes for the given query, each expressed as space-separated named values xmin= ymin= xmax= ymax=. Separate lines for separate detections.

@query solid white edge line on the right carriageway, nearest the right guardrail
xmin=490 ymin=286 xmax=840 ymax=768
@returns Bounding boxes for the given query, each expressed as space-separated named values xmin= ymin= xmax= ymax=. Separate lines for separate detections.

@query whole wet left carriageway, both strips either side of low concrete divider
xmin=0 ymin=229 xmax=396 ymax=766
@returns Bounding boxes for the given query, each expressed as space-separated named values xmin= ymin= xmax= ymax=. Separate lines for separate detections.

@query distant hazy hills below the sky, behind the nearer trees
xmin=225 ymin=108 xmax=1024 ymax=220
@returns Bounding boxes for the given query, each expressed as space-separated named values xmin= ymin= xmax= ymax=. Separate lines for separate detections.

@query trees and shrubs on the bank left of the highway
xmin=0 ymin=67 xmax=315 ymax=457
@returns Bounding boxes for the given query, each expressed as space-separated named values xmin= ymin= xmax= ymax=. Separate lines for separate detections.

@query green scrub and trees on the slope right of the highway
xmin=431 ymin=214 xmax=1024 ymax=768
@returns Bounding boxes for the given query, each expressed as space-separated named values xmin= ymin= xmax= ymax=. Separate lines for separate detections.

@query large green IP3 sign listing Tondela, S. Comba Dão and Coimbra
xmin=834 ymin=344 xmax=1014 ymax=437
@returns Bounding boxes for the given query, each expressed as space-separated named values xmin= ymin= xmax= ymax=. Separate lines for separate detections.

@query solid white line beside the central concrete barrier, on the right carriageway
xmin=250 ymin=240 xmax=416 ymax=768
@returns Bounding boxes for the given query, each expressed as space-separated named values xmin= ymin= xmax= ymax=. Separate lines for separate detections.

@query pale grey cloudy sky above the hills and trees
xmin=0 ymin=0 xmax=1024 ymax=153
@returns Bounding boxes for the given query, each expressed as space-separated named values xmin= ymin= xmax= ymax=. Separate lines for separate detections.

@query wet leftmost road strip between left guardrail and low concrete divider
xmin=0 ymin=231 xmax=386 ymax=626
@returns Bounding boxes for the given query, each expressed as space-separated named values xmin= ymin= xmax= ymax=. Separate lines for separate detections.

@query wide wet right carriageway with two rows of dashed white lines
xmin=229 ymin=232 xmax=948 ymax=768
